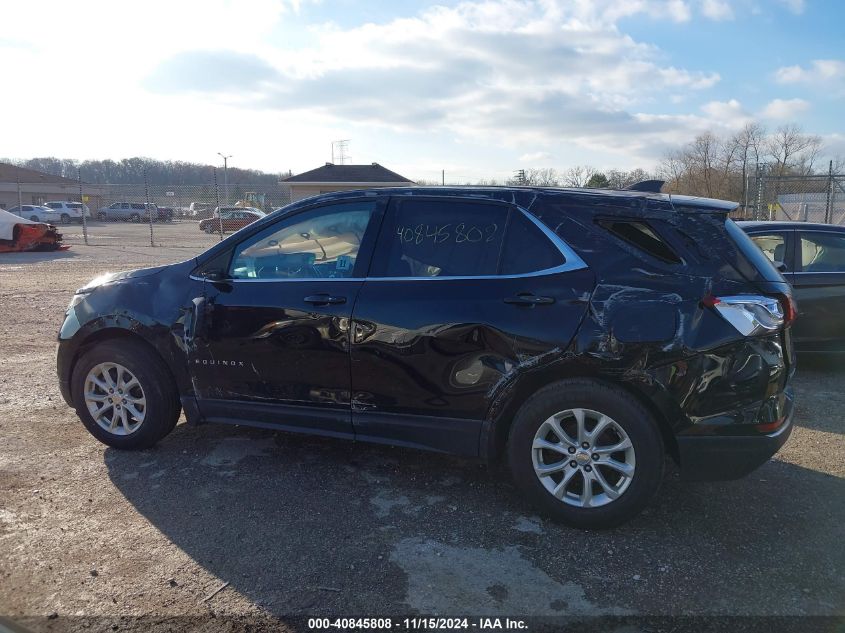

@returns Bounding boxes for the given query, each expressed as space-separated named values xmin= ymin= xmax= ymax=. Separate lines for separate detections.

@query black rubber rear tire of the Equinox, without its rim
xmin=508 ymin=379 xmax=664 ymax=529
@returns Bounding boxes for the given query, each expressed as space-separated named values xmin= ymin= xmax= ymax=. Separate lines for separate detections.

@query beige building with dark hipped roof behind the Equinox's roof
xmin=281 ymin=163 xmax=414 ymax=202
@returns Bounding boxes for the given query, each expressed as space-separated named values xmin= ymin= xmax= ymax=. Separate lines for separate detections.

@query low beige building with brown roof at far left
xmin=0 ymin=163 xmax=105 ymax=209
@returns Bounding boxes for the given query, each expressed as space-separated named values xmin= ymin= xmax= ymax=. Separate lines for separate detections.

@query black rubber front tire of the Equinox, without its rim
xmin=71 ymin=340 xmax=181 ymax=450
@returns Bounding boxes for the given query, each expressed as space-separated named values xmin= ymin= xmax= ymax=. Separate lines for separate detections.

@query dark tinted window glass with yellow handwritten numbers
xmin=374 ymin=199 xmax=508 ymax=277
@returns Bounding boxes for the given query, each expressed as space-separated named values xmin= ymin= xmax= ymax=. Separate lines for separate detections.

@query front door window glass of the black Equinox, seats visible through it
xmin=229 ymin=200 xmax=376 ymax=279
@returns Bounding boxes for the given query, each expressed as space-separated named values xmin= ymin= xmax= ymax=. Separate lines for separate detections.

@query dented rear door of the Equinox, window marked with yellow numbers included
xmin=352 ymin=196 xmax=593 ymax=455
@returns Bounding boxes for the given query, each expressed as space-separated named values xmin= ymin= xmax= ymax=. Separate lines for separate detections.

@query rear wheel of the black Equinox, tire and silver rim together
xmin=508 ymin=379 xmax=663 ymax=529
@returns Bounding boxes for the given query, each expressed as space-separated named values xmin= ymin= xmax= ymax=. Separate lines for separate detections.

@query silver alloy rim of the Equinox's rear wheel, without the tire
xmin=531 ymin=409 xmax=636 ymax=508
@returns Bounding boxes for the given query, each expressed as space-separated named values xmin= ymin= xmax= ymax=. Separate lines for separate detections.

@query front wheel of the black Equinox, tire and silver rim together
xmin=71 ymin=340 xmax=180 ymax=450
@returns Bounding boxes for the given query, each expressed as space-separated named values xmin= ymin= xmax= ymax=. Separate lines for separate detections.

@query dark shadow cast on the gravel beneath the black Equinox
xmin=105 ymin=425 xmax=845 ymax=616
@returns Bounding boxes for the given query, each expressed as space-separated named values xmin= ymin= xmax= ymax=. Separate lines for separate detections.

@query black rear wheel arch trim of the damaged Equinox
xmin=480 ymin=365 xmax=678 ymax=461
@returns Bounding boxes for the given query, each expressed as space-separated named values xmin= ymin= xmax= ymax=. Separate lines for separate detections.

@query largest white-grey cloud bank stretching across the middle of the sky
xmin=146 ymin=0 xmax=732 ymax=159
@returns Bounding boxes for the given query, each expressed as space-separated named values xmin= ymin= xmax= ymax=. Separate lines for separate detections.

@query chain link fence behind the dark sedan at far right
xmin=734 ymin=172 xmax=845 ymax=224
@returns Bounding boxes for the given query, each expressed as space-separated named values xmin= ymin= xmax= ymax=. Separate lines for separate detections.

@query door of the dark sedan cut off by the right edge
xmin=790 ymin=228 xmax=845 ymax=352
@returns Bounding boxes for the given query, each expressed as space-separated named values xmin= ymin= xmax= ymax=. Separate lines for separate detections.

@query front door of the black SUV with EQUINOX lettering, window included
xmin=189 ymin=200 xmax=380 ymax=435
